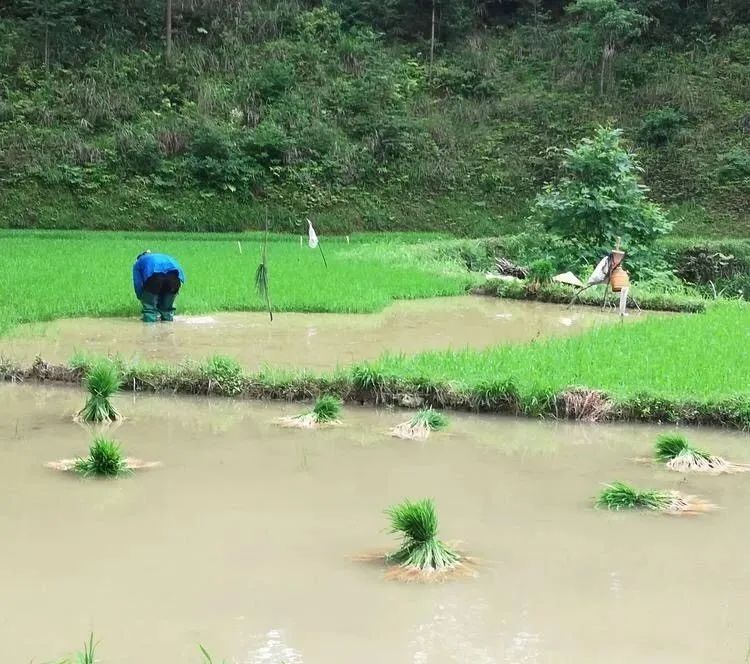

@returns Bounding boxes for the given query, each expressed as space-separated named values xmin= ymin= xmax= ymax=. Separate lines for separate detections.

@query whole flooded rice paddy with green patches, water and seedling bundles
xmin=0 ymin=227 xmax=750 ymax=664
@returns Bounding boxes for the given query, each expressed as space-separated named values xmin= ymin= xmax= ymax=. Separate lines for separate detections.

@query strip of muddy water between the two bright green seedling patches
xmin=0 ymin=296 xmax=640 ymax=369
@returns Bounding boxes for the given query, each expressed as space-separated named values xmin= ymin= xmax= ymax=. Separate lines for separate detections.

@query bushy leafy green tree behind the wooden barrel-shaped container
xmin=535 ymin=127 xmax=672 ymax=258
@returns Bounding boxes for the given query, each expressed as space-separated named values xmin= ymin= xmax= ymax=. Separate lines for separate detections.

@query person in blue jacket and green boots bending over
xmin=133 ymin=251 xmax=185 ymax=323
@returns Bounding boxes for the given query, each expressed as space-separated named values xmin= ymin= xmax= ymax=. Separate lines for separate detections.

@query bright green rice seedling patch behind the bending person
xmin=0 ymin=231 xmax=476 ymax=333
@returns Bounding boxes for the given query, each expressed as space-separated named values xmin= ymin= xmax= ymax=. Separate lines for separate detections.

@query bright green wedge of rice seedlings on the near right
xmin=368 ymin=302 xmax=750 ymax=400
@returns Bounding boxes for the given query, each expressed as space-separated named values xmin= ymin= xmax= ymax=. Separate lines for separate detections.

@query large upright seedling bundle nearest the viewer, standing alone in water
xmin=386 ymin=499 xmax=473 ymax=581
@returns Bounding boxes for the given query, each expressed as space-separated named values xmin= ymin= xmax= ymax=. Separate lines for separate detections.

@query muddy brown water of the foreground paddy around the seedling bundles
xmin=0 ymin=385 xmax=750 ymax=664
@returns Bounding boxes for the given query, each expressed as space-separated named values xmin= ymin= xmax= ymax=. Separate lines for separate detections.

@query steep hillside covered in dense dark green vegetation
xmin=0 ymin=0 xmax=750 ymax=236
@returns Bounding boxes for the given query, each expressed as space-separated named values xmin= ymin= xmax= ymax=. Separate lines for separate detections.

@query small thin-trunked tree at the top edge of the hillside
xmin=567 ymin=0 xmax=649 ymax=94
